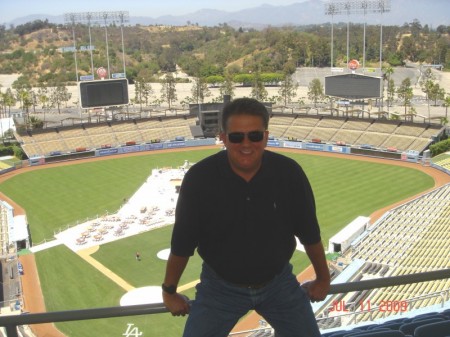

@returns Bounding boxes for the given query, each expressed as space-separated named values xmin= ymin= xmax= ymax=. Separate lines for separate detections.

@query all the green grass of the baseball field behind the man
xmin=0 ymin=149 xmax=434 ymax=337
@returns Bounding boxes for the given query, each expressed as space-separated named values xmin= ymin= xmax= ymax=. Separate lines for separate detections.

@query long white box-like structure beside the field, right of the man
xmin=328 ymin=216 xmax=370 ymax=253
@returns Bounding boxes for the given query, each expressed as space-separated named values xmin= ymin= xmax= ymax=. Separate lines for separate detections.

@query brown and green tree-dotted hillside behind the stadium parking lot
xmin=0 ymin=21 xmax=450 ymax=86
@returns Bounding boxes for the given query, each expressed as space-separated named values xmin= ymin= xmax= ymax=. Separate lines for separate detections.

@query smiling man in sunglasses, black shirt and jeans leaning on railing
xmin=162 ymin=98 xmax=330 ymax=337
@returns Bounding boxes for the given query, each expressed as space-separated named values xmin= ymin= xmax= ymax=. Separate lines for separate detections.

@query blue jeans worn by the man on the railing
xmin=183 ymin=263 xmax=320 ymax=337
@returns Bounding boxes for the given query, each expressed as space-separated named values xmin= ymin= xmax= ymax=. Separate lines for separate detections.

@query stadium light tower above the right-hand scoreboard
xmin=325 ymin=0 xmax=391 ymax=70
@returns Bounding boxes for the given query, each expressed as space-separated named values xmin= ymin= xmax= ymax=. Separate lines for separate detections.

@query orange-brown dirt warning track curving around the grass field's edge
xmin=0 ymin=145 xmax=450 ymax=337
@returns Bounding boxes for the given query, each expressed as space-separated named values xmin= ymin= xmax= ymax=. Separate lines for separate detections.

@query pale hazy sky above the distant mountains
xmin=0 ymin=0 xmax=305 ymax=23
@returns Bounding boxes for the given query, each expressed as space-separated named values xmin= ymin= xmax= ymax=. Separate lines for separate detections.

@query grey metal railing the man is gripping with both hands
xmin=0 ymin=269 xmax=450 ymax=337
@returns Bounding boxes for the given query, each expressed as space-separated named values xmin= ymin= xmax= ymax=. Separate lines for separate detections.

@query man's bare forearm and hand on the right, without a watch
xmin=303 ymin=241 xmax=331 ymax=302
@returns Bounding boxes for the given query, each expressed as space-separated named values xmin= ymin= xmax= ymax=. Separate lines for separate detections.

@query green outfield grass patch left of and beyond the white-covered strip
xmin=0 ymin=150 xmax=217 ymax=244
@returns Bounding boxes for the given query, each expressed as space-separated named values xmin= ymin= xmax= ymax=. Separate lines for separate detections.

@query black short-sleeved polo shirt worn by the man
xmin=171 ymin=151 xmax=321 ymax=283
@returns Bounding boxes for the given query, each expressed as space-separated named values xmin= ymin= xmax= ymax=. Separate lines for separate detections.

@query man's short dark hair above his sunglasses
xmin=222 ymin=97 xmax=269 ymax=132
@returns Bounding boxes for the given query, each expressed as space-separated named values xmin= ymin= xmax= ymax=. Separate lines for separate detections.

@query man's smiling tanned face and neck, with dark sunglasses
xmin=220 ymin=115 xmax=269 ymax=181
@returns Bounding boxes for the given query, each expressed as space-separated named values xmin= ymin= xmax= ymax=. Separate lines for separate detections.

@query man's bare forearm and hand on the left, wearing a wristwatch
xmin=162 ymin=253 xmax=189 ymax=316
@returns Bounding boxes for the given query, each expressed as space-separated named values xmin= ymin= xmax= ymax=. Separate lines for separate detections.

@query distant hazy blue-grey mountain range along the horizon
xmin=4 ymin=0 xmax=450 ymax=29
